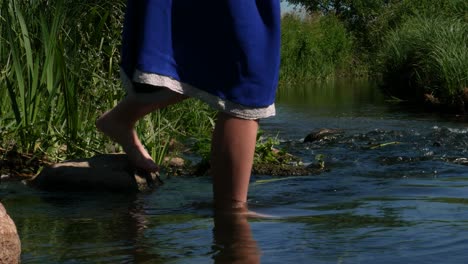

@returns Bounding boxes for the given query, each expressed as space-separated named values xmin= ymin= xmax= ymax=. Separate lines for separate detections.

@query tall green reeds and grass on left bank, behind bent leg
xmin=0 ymin=0 xmax=214 ymax=165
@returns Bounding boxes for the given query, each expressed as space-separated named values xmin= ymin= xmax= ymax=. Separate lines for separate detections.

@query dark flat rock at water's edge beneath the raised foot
xmin=28 ymin=154 xmax=162 ymax=192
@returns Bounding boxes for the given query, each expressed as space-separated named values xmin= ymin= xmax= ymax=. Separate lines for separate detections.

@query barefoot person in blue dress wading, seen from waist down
xmin=96 ymin=0 xmax=280 ymax=208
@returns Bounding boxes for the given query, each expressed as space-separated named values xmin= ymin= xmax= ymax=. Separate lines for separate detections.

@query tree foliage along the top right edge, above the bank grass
xmin=287 ymin=0 xmax=468 ymax=52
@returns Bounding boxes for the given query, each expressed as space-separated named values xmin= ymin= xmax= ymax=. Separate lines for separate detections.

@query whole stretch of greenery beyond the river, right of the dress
xmin=282 ymin=0 xmax=468 ymax=112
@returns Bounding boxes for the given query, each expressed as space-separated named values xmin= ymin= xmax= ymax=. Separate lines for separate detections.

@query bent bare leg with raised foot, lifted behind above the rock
xmin=96 ymin=88 xmax=185 ymax=172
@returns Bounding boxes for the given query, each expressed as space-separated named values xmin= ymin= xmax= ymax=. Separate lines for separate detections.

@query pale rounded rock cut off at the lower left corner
xmin=0 ymin=203 xmax=21 ymax=264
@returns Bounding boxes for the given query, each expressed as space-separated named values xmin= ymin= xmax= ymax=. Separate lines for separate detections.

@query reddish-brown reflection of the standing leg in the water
xmin=213 ymin=213 xmax=261 ymax=264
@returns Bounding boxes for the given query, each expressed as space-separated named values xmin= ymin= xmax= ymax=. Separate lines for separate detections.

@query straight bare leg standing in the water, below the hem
xmin=211 ymin=113 xmax=258 ymax=209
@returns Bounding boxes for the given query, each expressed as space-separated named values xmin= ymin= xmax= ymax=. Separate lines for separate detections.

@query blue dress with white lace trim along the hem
xmin=121 ymin=0 xmax=280 ymax=118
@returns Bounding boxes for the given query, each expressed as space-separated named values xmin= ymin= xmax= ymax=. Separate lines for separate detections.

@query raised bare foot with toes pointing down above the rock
xmin=96 ymin=110 xmax=159 ymax=172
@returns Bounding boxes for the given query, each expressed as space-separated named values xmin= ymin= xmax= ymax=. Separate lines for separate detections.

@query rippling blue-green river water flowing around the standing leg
xmin=0 ymin=81 xmax=468 ymax=263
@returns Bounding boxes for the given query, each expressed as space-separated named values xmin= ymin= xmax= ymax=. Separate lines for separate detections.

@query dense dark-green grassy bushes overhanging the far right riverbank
xmin=286 ymin=0 xmax=468 ymax=108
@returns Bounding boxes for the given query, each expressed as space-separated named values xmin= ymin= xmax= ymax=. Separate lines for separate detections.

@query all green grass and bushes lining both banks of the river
xmin=0 ymin=0 xmax=468 ymax=175
